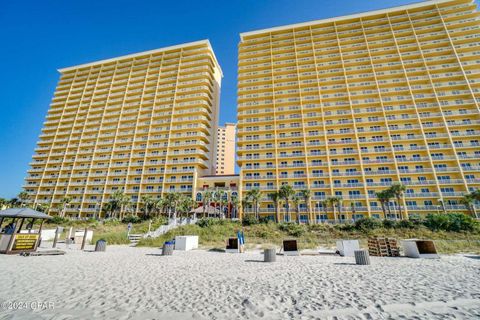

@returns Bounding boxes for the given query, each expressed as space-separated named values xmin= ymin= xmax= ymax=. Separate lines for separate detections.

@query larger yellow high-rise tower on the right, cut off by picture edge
xmin=238 ymin=0 xmax=480 ymax=220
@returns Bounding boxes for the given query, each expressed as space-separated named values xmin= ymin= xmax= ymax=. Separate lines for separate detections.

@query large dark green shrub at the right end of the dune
xmin=424 ymin=213 xmax=479 ymax=232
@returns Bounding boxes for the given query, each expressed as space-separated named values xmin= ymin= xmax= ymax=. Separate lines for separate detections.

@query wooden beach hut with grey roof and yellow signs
xmin=0 ymin=208 xmax=52 ymax=254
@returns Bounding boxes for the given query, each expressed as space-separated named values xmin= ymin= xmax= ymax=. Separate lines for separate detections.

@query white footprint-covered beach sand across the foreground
xmin=0 ymin=246 xmax=480 ymax=319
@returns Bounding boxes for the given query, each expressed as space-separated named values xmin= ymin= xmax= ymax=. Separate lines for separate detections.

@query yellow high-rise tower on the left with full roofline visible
xmin=25 ymin=40 xmax=222 ymax=214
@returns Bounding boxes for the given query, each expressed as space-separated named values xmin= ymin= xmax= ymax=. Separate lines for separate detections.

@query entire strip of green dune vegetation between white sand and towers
xmin=36 ymin=214 xmax=480 ymax=253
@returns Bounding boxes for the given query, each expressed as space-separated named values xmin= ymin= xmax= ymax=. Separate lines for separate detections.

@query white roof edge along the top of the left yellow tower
xmin=58 ymin=39 xmax=223 ymax=77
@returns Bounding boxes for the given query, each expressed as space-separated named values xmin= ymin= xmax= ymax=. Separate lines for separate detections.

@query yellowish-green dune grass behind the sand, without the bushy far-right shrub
xmin=44 ymin=219 xmax=480 ymax=254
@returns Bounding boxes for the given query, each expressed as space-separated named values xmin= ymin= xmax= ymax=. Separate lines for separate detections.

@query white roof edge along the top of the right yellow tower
xmin=240 ymin=0 xmax=466 ymax=41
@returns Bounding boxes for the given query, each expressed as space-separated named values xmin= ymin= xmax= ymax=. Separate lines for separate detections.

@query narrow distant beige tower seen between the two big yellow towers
xmin=215 ymin=123 xmax=236 ymax=175
